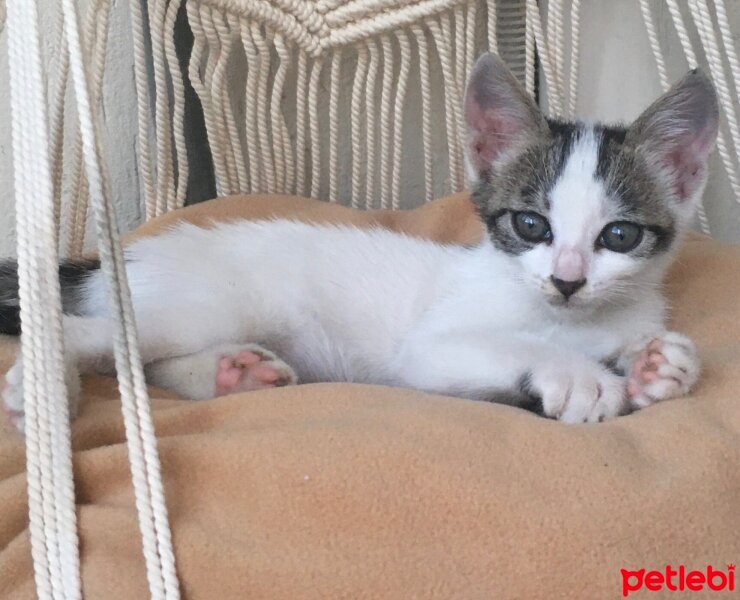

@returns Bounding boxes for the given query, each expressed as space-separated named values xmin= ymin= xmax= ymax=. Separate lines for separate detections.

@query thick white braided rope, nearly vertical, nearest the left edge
xmin=7 ymin=0 xmax=81 ymax=600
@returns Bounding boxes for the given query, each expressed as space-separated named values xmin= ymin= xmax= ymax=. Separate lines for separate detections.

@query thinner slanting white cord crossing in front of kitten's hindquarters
xmin=61 ymin=0 xmax=179 ymax=600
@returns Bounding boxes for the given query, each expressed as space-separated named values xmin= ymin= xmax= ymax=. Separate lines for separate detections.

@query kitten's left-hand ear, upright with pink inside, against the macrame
xmin=465 ymin=53 xmax=549 ymax=180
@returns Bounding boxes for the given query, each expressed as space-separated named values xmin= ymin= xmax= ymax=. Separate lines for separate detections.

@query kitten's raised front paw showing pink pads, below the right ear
xmin=627 ymin=331 xmax=700 ymax=408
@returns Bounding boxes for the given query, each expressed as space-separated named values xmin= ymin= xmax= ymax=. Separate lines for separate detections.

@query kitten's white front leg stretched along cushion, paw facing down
xmin=398 ymin=333 xmax=626 ymax=423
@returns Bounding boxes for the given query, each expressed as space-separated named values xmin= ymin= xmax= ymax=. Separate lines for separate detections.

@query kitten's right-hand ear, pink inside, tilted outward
xmin=626 ymin=69 xmax=719 ymax=202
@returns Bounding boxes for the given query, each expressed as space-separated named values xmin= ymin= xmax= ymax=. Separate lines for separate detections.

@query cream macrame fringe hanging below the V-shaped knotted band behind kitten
xmin=188 ymin=0 xmax=496 ymax=208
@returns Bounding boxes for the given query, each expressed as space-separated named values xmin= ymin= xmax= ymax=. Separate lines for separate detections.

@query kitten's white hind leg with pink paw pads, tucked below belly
xmin=146 ymin=344 xmax=297 ymax=400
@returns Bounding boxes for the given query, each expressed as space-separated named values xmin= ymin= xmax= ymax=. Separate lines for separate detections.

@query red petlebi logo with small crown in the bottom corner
xmin=621 ymin=563 xmax=735 ymax=598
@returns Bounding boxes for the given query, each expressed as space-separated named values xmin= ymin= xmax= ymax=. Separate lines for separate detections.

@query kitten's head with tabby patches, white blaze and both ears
xmin=465 ymin=54 xmax=718 ymax=310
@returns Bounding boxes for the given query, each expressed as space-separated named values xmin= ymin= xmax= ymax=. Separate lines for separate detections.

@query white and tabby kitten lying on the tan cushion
xmin=0 ymin=54 xmax=718 ymax=425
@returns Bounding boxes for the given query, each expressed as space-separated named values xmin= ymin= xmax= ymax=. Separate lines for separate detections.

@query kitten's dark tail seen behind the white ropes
xmin=0 ymin=259 xmax=100 ymax=335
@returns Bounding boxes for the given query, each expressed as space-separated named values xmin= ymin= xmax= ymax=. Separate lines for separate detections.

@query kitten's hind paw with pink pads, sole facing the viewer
xmin=216 ymin=346 xmax=298 ymax=396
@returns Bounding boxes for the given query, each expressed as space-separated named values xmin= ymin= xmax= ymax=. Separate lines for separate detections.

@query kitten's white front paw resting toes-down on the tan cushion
xmin=529 ymin=359 xmax=626 ymax=423
